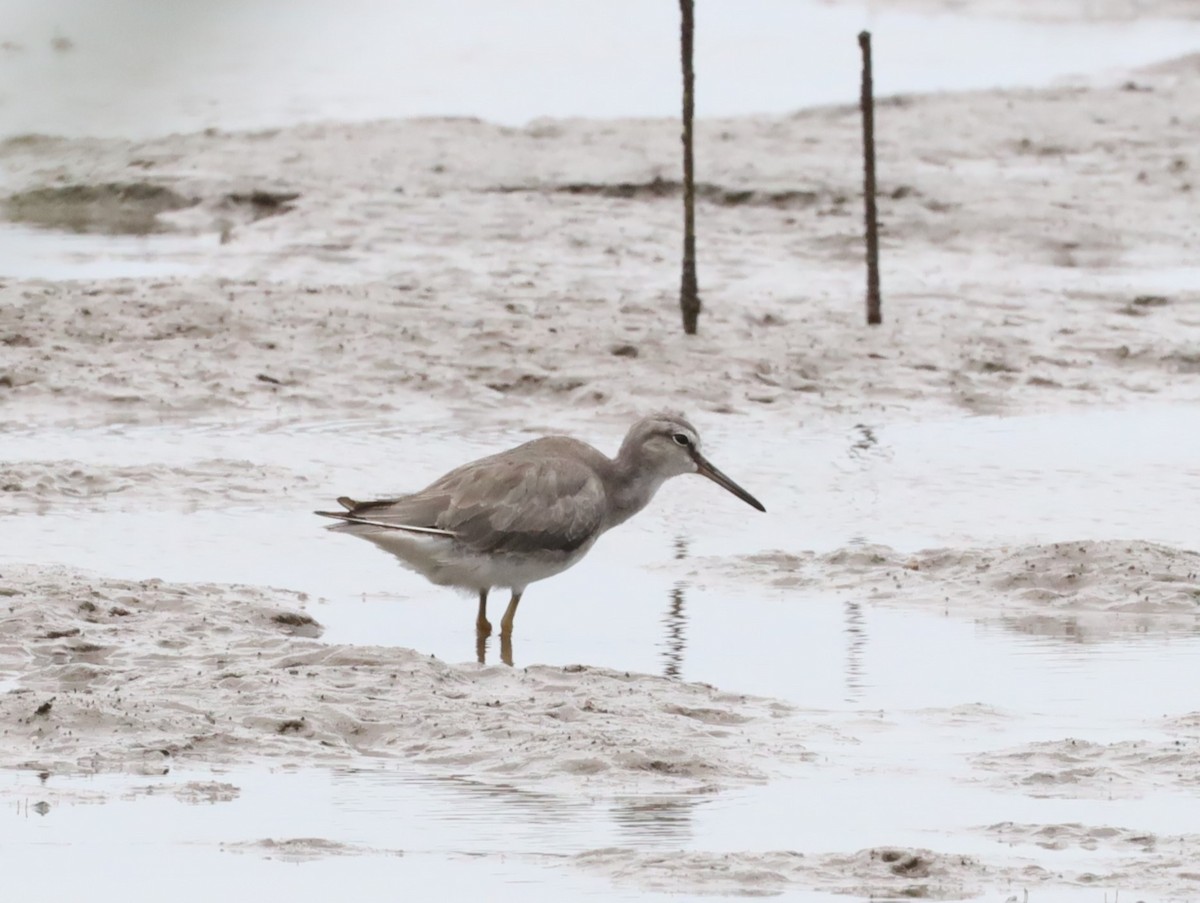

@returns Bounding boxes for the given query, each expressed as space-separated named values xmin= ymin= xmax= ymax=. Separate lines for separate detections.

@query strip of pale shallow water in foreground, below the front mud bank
xmin=0 ymin=759 xmax=1194 ymax=901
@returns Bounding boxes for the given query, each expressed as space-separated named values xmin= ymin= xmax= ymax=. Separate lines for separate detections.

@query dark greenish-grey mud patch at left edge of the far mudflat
xmin=4 ymin=181 xmax=198 ymax=235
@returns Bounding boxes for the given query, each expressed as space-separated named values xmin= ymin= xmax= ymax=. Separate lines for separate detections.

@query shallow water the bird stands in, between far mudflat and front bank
xmin=0 ymin=405 xmax=1200 ymax=691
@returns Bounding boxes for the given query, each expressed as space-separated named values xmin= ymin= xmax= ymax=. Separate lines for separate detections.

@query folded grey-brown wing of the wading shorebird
xmin=331 ymin=453 xmax=606 ymax=552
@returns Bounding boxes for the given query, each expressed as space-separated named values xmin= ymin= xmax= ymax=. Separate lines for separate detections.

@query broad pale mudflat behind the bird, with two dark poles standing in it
xmin=0 ymin=52 xmax=1200 ymax=423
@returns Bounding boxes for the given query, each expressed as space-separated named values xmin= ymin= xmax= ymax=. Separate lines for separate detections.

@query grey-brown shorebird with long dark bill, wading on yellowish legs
xmin=316 ymin=413 xmax=767 ymax=638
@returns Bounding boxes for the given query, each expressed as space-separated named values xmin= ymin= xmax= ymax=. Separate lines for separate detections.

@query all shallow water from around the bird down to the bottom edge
xmin=0 ymin=405 xmax=1200 ymax=901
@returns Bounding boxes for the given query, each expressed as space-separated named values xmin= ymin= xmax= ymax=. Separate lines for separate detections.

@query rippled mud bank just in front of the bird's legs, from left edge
xmin=0 ymin=567 xmax=806 ymax=790
